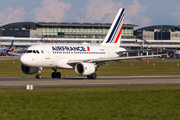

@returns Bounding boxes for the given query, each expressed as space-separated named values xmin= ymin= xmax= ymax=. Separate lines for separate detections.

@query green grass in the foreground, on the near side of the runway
xmin=0 ymin=85 xmax=180 ymax=120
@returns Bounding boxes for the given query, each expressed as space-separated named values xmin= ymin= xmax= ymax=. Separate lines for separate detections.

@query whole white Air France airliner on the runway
xmin=9 ymin=8 xmax=161 ymax=79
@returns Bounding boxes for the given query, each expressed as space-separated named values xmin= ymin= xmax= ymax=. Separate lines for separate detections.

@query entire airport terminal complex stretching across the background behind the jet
xmin=0 ymin=22 xmax=180 ymax=54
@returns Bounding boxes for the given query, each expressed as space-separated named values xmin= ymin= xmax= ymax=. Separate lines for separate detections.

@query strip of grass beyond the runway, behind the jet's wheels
xmin=0 ymin=59 xmax=180 ymax=77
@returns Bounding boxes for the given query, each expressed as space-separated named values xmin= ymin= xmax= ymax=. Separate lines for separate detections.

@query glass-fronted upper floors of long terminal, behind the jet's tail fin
xmin=0 ymin=22 xmax=136 ymax=39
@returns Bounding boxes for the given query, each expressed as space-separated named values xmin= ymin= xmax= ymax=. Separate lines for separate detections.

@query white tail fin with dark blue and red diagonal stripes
xmin=102 ymin=8 xmax=125 ymax=47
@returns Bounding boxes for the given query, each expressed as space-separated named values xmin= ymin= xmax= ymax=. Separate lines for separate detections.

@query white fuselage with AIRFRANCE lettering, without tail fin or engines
xmin=20 ymin=44 xmax=125 ymax=69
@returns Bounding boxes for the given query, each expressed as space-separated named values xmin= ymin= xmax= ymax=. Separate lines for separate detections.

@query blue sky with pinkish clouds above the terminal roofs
xmin=0 ymin=0 xmax=180 ymax=27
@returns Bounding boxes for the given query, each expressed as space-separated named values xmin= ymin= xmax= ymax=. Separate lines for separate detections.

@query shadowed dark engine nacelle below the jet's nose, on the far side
xmin=21 ymin=64 xmax=38 ymax=74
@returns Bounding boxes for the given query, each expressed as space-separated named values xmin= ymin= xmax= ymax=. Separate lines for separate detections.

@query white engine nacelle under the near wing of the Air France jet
xmin=75 ymin=63 xmax=96 ymax=75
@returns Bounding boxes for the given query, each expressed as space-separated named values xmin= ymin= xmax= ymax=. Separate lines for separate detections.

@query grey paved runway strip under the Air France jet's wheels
xmin=0 ymin=76 xmax=180 ymax=87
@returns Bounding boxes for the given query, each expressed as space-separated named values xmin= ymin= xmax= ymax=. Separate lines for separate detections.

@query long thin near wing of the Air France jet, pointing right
xmin=68 ymin=54 xmax=161 ymax=64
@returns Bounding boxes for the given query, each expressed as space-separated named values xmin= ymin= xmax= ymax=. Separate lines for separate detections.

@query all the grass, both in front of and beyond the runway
xmin=0 ymin=60 xmax=180 ymax=120
